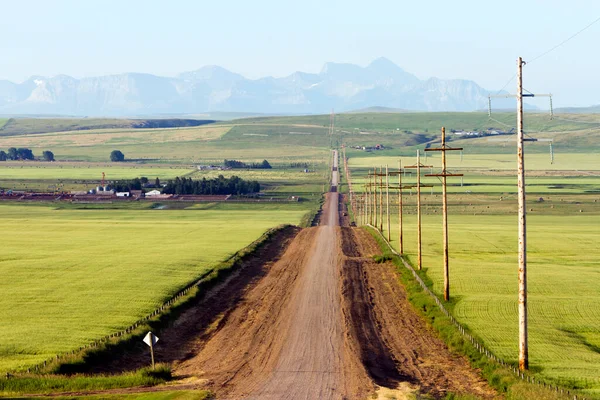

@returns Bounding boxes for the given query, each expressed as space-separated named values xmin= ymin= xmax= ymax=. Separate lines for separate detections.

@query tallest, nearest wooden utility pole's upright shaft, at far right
xmin=517 ymin=57 xmax=529 ymax=371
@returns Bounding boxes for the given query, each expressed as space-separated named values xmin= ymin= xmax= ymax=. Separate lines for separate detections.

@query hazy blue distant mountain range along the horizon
xmin=0 ymin=58 xmax=524 ymax=116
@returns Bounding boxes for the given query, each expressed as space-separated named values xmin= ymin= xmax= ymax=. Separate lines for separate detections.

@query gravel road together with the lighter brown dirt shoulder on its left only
xmin=176 ymin=150 xmax=369 ymax=399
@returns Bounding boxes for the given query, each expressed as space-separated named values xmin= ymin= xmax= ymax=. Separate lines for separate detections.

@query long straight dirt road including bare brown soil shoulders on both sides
xmin=90 ymin=151 xmax=495 ymax=400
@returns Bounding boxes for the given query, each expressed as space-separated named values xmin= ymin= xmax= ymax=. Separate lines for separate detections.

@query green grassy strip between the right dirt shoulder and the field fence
xmin=365 ymin=227 xmax=600 ymax=400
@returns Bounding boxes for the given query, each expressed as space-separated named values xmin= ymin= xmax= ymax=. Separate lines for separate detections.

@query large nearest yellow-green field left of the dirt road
xmin=0 ymin=204 xmax=307 ymax=371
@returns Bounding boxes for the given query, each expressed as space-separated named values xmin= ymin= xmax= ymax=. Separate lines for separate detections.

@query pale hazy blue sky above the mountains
xmin=0 ymin=0 xmax=600 ymax=106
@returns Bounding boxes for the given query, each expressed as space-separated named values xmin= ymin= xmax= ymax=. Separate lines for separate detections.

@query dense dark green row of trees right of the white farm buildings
xmin=163 ymin=175 xmax=260 ymax=195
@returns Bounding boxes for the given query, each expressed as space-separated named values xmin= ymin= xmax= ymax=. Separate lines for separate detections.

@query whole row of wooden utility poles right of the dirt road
xmin=353 ymin=57 xmax=536 ymax=371
